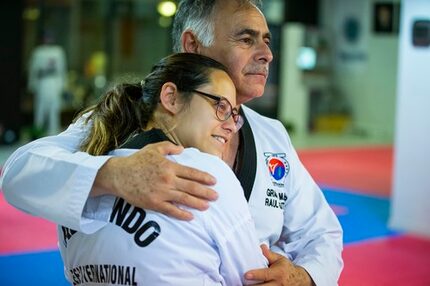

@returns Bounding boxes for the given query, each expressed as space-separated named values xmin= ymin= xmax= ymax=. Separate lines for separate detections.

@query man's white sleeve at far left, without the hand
xmin=1 ymin=115 xmax=111 ymax=233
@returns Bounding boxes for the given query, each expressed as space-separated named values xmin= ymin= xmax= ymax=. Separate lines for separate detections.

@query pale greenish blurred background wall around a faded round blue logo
xmin=321 ymin=0 xmax=399 ymax=142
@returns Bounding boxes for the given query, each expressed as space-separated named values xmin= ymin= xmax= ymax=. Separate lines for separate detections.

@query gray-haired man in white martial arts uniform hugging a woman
xmin=3 ymin=0 xmax=342 ymax=285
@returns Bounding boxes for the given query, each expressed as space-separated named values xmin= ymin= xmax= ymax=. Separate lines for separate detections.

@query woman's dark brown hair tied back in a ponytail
xmin=78 ymin=53 xmax=227 ymax=155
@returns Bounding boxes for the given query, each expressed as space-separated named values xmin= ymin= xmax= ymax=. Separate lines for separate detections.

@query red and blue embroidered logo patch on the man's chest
xmin=264 ymin=152 xmax=290 ymax=187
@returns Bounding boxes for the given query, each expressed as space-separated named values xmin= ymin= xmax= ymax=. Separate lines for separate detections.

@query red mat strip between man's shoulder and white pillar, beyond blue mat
xmin=299 ymin=146 xmax=393 ymax=196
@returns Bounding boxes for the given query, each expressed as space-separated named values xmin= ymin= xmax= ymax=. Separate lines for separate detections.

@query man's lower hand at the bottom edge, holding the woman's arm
xmin=245 ymin=244 xmax=314 ymax=286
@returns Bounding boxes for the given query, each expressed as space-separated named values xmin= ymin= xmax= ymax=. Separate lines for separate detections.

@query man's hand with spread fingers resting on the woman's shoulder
xmin=91 ymin=142 xmax=218 ymax=220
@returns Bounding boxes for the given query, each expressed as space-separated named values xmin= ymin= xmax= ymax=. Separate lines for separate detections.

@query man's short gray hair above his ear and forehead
xmin=172 ymin=0 xmax=262 ymax=53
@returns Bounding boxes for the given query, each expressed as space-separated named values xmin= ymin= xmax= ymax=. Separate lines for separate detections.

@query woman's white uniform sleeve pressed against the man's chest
xmin=176 ymin=153 xmax=267 ymax=285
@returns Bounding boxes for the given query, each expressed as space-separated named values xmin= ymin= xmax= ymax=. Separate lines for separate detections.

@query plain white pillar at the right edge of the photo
xmin=390 ymin=0 xmax=430 ymax=236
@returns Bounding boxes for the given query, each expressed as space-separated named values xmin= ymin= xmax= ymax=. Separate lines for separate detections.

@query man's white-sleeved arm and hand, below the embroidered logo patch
xmin=242 ymin=116 xmax=343 ymax=286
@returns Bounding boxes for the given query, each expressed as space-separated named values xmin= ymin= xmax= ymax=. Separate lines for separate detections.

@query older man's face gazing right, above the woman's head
xmin=200 ymin=1 xmax=273 ymax=104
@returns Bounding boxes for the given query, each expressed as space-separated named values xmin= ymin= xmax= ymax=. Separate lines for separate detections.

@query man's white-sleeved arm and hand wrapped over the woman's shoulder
xmin=1 ymin=115 xmax=216 ymax=233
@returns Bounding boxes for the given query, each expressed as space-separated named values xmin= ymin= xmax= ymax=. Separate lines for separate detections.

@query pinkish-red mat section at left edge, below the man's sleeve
xmin=0 ymin=193 xmax=57 ymax=254
